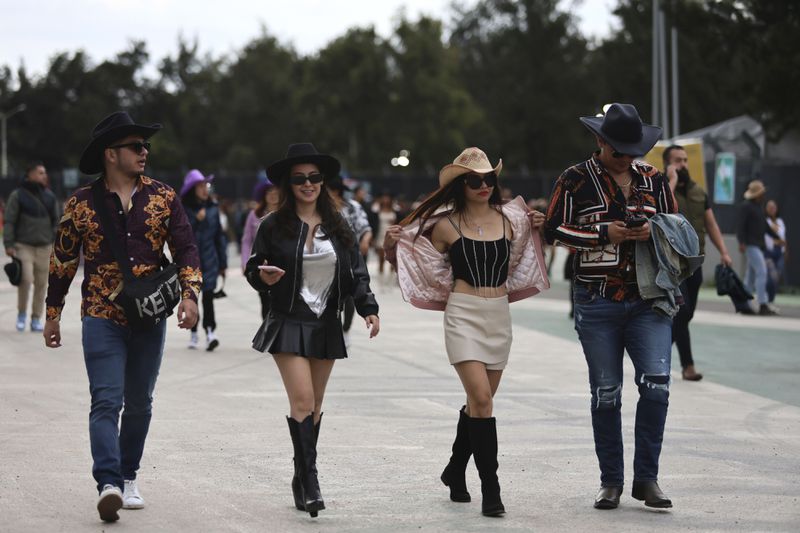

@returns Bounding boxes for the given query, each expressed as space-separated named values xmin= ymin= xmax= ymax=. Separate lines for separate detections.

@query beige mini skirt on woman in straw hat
xmin=444 ymin=292 xmax=511 ymax=370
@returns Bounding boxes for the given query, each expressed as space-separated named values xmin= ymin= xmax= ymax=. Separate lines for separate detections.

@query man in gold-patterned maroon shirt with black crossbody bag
xmin=44 ymin=112 xmax=202 ymax=522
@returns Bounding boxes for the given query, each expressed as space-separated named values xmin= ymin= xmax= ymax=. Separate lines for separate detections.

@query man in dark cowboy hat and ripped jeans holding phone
xmin=545 ymin=104 xmax=677 ymax=509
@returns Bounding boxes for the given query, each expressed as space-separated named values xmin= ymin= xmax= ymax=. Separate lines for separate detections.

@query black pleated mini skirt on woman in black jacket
xmin=253 ymin=299 xmax=347 ymax=359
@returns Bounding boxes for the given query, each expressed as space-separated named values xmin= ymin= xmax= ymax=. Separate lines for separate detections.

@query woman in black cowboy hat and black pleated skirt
xmin=245 ymin=143 xmax=380 ymax=516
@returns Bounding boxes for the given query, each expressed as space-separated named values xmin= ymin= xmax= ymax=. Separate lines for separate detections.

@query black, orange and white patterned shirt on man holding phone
xmin=545 ymin=154 xmax=677 ymax=301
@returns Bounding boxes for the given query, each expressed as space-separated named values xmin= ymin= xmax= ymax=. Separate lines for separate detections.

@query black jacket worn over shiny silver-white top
xmin=245 ymin=213 xmax=378 ymax=317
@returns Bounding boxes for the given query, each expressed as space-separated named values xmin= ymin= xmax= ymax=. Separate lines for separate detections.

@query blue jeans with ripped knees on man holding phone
xmin=574 ymin=285 xmax=672 ymax=487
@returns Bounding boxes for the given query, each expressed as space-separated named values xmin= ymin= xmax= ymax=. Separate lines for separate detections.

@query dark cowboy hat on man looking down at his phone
xmin=581 ymin=104 xmax=661 ymax=157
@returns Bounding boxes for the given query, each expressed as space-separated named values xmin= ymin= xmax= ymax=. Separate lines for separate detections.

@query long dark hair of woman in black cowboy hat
xmin=275 ymin=175 xmax=355 ymax=248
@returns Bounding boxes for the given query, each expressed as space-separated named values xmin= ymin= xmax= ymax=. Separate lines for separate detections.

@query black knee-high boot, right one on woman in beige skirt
xmin=469 ymin=417 xmax=506 ymax=516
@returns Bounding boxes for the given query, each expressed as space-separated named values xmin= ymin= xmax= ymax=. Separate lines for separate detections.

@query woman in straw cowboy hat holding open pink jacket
xmin=384 ymin=148 xmax=550 ymax=516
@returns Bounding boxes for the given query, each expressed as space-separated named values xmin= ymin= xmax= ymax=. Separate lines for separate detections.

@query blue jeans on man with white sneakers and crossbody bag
xmin=83 ymin=316 xmax=167 ymax=491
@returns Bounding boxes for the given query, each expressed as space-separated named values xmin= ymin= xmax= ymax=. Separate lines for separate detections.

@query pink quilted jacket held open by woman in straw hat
xmin=387 ymin=196 xmax=550 ymax=311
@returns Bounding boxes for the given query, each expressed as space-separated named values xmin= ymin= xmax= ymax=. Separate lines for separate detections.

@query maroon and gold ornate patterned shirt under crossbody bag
xmin=46 ymin=176 xmax=202 ymax=325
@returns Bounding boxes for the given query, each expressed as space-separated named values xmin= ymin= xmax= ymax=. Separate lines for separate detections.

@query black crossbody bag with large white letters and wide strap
xmin=92 ymin=179 xmax=181 ymax=331
